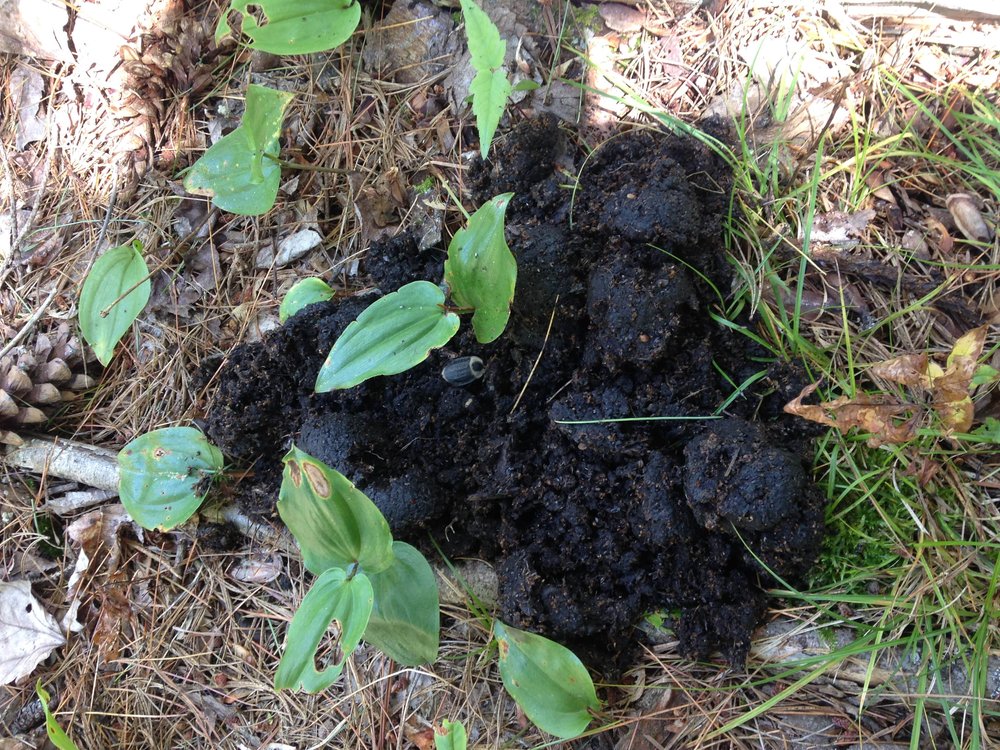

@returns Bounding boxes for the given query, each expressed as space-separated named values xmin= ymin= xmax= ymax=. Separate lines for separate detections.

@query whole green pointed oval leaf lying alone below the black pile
xmin=495 ymin=620 xmax=601 ymax=740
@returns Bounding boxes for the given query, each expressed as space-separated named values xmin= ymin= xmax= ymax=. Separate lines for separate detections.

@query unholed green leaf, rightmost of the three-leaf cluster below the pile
xmin=365 ymin=542 xmax=441 ymax=667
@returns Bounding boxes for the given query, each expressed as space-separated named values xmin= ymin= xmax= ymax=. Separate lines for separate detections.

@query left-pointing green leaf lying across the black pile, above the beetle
xmin=316 ymin=281 xmax=459 ymax=393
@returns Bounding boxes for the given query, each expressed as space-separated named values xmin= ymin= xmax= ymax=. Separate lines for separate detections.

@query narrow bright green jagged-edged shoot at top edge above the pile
xmin=461 ymin=0 xmax=512 ymax=159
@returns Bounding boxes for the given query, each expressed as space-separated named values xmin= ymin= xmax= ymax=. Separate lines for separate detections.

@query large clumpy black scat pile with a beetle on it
xmin=201 ymin=120 xmax=823 ymax=670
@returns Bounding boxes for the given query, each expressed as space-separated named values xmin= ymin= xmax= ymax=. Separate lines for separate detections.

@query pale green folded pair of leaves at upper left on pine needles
xmin=184 ymin=84 xmax=293 ymax=216
